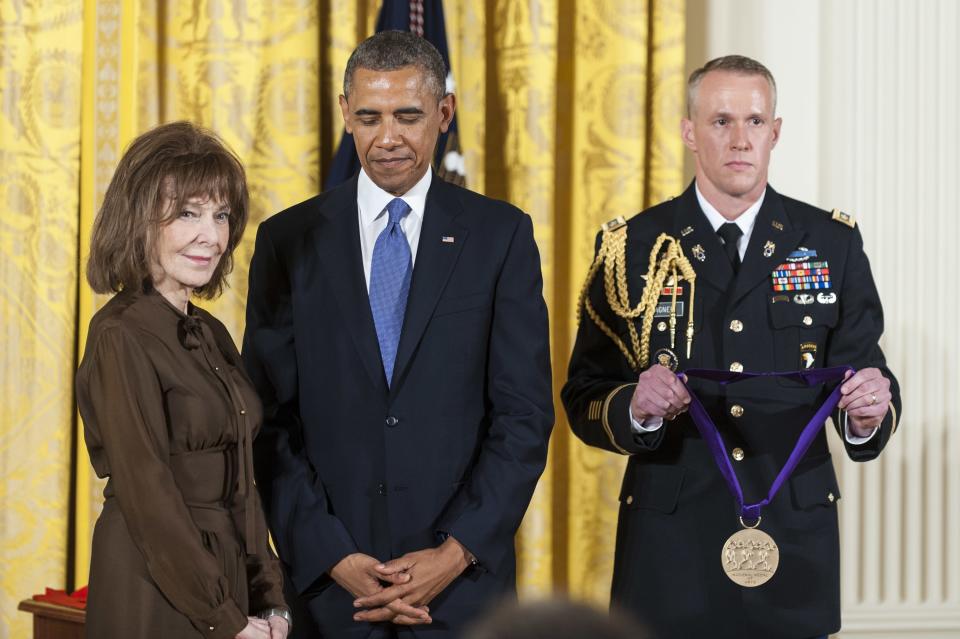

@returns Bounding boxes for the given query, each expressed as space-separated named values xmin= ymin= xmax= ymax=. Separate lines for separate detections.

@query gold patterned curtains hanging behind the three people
xmin=0 ymin=0 xmax=684 ymax=639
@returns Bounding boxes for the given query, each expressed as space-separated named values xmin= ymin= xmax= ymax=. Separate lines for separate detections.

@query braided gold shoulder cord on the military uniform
xmin=577 ymin=224 xmax=697 ymax=371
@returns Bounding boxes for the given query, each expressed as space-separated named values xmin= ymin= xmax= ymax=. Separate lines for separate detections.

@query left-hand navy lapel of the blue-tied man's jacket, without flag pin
xmin=311 ymin=178 xmax=386 ymax=392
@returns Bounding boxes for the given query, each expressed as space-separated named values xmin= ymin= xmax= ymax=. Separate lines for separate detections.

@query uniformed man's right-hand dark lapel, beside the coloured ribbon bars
xmin=730 ymin=186 xmax=804 ymax=304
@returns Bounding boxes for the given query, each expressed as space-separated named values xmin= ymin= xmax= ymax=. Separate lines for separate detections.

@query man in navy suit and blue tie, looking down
xmin=244 ymin=31 xmax=553 ymax=637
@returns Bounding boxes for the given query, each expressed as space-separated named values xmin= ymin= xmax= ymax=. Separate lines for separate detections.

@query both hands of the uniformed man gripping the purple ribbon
xmin=630 ymin=366 xmax=893 ymax=437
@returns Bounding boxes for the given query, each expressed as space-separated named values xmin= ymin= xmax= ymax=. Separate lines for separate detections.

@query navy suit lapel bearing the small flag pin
xmin=391 ymin=175 xmax=467 ymax=389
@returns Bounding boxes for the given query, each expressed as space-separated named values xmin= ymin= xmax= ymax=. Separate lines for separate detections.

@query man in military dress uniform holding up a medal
xmin=562 ymin=56 xmax=900 ymax=639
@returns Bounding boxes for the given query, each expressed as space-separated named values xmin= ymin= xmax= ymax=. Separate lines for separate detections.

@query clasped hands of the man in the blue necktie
xmin=330 ymin=537 xmax=470 ymax=626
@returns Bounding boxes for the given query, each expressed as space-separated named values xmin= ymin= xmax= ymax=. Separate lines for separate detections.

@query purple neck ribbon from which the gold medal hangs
xmin=677 ymin=366 xmax=853 ymax=521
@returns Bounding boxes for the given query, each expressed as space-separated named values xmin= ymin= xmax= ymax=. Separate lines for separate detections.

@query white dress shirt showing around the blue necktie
xmin=357 ymin=169 xmax=433 ymax=292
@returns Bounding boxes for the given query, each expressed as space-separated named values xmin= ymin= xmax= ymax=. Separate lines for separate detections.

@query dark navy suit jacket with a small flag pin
xmin=243 ymin=177 xmax=554 ymax=637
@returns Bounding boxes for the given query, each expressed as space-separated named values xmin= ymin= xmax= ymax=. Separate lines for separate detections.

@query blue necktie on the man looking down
xmin=370 ymin=198 xmax=413 ymax=386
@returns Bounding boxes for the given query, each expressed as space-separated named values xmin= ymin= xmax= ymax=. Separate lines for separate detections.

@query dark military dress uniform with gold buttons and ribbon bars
xmin=562 ymin=184 xmax=901 ymax=639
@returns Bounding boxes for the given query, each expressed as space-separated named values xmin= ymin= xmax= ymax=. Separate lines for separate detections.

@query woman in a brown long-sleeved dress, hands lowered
xmin=77 ymin=122 xmax=291 ymax=639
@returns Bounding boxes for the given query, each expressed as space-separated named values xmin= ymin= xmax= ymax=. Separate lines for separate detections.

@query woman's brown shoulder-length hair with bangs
xmin=87 ymin=122 xmax=249 ymax=299
